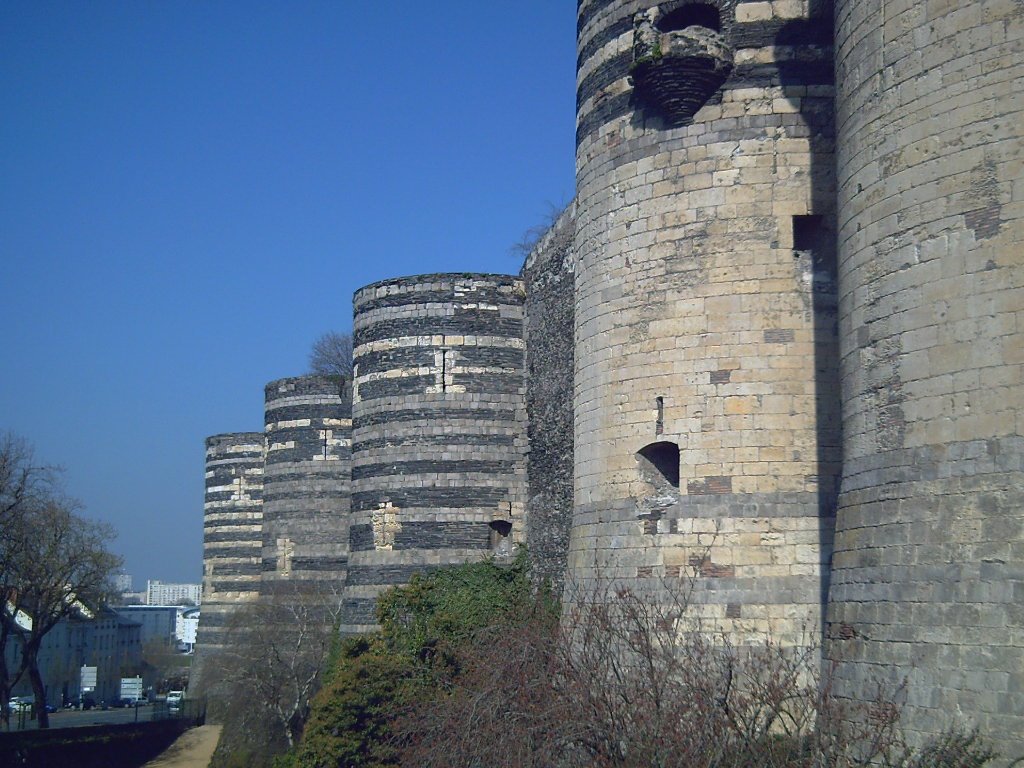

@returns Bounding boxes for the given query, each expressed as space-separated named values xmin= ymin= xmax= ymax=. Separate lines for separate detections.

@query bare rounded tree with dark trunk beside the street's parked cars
xmin=6 ymin=497 xmax=121 ymax=728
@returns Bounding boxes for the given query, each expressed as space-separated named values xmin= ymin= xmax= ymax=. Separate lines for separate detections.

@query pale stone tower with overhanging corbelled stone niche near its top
xmin=568 ymin=0 xmax=840 ymax=643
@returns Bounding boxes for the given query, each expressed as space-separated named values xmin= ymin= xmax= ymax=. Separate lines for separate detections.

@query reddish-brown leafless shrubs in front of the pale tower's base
xmin=398 ymin=578 xmax=991 ymax=768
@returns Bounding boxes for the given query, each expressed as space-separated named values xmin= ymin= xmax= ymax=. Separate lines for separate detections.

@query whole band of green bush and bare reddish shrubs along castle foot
xmin=225 ymin=555 xmax=993 ymax=768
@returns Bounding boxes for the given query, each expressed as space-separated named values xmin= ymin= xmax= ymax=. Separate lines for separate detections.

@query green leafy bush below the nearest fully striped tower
xmin=281 ymin=553 xmax=544 ymax=768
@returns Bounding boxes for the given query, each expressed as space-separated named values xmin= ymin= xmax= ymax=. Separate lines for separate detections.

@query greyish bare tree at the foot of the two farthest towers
xmin=210 ymin=587 xmax=340 ymax=748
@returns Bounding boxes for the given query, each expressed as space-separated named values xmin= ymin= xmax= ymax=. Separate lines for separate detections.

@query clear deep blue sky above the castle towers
xmin=0 ymin=0 xmax=575 ymax=587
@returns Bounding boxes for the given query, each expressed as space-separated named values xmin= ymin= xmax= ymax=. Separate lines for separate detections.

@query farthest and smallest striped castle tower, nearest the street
xmin=193 ymin=432 xmax=263 ymax=688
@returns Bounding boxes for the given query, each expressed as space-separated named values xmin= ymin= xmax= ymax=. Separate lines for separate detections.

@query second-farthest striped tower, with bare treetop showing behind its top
xmin=263 ymin=376 xmax=352 ymax=602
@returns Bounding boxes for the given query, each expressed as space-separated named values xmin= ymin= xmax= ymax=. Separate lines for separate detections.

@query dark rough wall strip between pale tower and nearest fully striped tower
xmin=522 ymin=204 xmax=575 ymax=592
